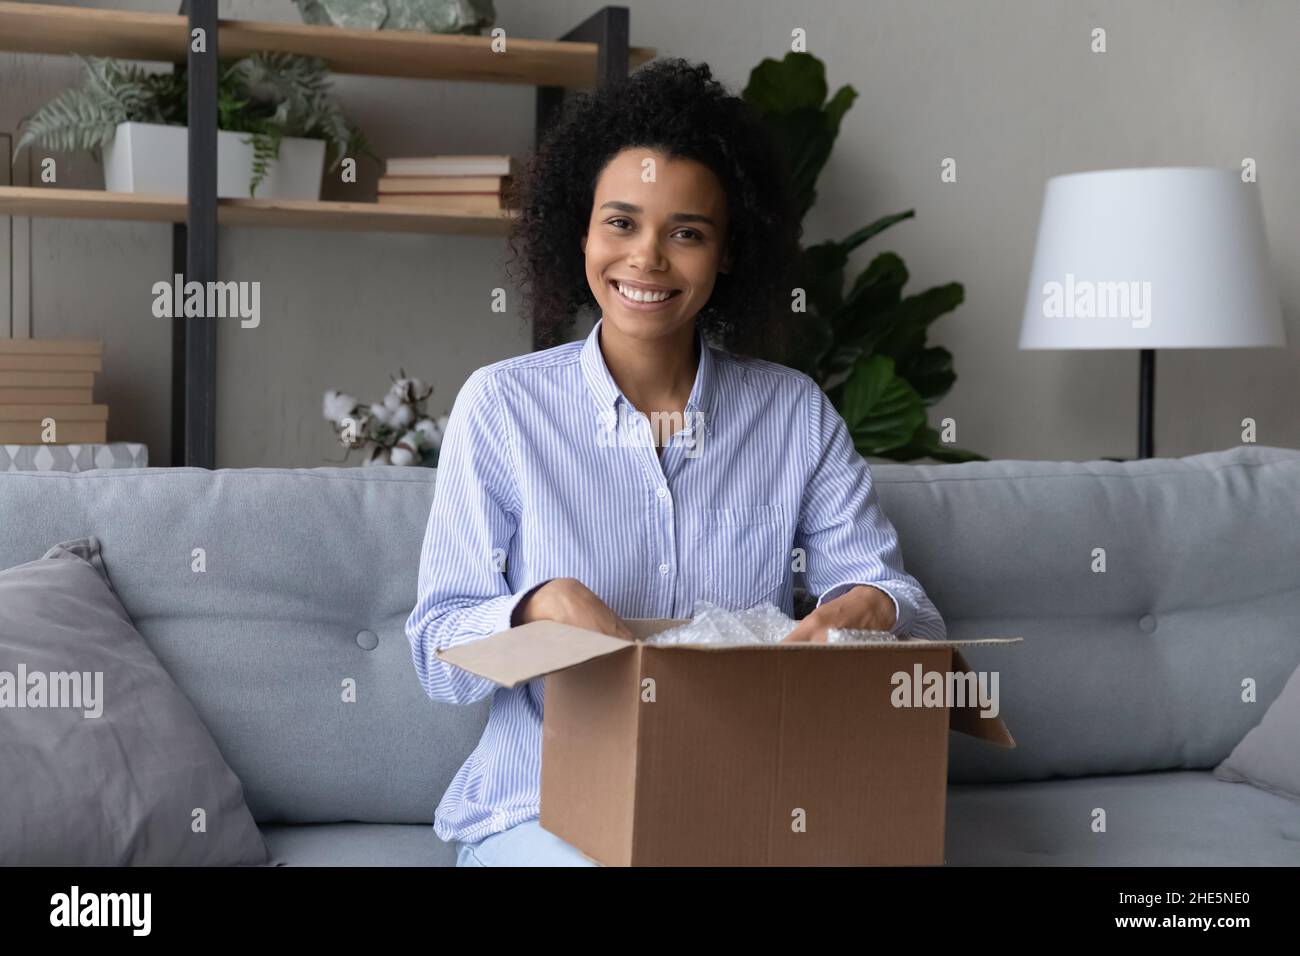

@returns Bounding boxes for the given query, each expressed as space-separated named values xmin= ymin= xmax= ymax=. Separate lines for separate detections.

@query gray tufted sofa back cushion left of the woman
xmin=0 ymin=468 xmax=489 ymax=825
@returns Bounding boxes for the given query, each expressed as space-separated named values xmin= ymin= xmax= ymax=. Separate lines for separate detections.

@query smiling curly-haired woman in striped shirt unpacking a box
xmin=406 ymin=60 xmax=945 ymax=866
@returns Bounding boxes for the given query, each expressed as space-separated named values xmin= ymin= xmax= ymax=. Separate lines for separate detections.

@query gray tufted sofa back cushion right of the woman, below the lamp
xmin=872 ymin=445 xmax=1300 ymax=783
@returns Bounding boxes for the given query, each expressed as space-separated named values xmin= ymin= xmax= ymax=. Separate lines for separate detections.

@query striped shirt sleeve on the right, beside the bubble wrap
xmin=796 ymin=378 xmax=948 ymax=640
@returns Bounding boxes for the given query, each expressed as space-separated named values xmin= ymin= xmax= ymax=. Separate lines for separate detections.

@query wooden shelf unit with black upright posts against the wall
xmin=0 ymin=0 xmax=644 ymax=468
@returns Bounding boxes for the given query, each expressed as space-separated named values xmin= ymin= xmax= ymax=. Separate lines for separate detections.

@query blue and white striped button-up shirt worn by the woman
xmin=406 ymin=319 xmax=946 ymax=843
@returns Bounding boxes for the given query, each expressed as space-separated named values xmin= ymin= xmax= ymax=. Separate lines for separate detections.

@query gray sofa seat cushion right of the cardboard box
xmin=946 ymin=770 xmax=1300 ymax=866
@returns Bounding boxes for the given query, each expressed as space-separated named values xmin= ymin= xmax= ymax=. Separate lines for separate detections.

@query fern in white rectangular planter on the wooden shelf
xmin=14 ymin=53 xmax=373 ymax=199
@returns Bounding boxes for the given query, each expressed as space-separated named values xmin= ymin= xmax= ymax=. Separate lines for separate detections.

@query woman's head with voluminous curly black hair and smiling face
xmin=508 ymin=59 xmax=801 ymax=351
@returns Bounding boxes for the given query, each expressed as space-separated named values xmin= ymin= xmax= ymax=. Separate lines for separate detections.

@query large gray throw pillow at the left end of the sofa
xmin=0 ymin=537 xmax=269 ymax=866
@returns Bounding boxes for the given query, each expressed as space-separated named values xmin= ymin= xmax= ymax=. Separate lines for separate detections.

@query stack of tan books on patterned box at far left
xmin=0 ymin=338 xmax=108 ymax=445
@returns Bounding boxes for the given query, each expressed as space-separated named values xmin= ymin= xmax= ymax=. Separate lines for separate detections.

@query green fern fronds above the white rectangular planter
xmin=14 ymin=53 xmax=374 ymax=194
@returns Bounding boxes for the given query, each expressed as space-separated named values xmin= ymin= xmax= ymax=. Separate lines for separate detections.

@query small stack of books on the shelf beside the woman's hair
xmin=380 ymin=156 xmax=519 ymax=212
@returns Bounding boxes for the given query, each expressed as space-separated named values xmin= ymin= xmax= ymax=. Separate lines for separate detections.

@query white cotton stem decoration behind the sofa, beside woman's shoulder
xmin=322 ymin=369 xmax=447 ymax=468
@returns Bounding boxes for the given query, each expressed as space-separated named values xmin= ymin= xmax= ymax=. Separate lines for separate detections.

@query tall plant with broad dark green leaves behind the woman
xmin=744 ymin=52 xmax=985 ymax=462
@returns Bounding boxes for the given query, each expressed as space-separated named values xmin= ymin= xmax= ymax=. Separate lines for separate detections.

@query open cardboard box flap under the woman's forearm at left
xmin=437 ymin=620 xmax=636 ymax=687
